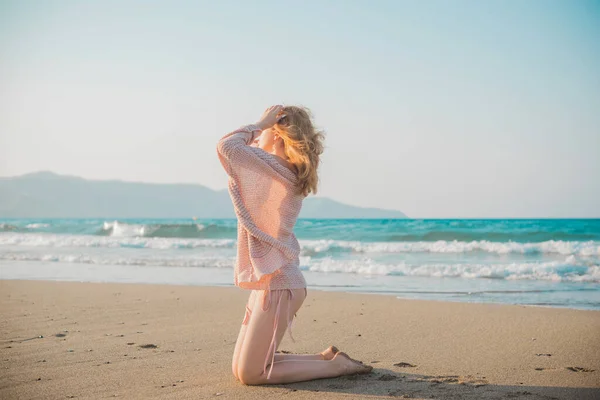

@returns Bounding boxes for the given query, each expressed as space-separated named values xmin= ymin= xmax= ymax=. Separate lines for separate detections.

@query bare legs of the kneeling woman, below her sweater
xmin=237 ymin=289 xmax=371 ymax=385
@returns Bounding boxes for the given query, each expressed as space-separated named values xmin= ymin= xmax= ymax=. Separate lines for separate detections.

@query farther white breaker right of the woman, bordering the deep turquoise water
xmin=300 ymin=240 xmax=600 ymax=256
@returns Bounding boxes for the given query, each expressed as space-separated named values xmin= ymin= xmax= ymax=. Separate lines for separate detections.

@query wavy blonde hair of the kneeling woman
xmin=275 ymin=106 xmax=325 ymax=196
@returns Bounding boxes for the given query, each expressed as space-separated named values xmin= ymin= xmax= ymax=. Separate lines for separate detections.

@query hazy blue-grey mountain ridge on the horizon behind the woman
xmin=0 ymin=172 xmax=406 ymax=218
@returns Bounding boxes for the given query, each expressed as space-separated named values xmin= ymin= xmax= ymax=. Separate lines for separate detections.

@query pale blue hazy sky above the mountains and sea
xmin=0 ymin=0 xmax=600 ymax=218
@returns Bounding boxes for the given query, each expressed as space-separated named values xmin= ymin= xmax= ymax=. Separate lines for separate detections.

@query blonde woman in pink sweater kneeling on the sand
xmin=217 ymin=105 xmax=372 ymax=385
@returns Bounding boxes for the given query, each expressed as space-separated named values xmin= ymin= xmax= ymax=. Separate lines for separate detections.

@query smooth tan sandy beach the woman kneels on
xmin=0 ymin=280 xmax=600 ymax=399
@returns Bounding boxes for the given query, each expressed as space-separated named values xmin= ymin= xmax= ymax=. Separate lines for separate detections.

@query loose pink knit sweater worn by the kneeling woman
xmin=217 ymin=125 xmax=306 ymax=290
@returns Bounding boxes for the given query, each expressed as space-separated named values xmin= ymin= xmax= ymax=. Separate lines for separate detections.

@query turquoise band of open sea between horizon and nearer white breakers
xmin=0 ymin=218 xmax=600 ymax=243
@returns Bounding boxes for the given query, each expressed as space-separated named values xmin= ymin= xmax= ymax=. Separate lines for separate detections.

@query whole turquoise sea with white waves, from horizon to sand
xmin=0 ymin=219 xmax=600 ymax=310
